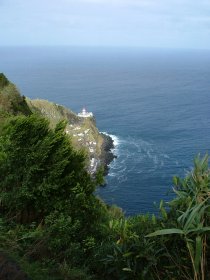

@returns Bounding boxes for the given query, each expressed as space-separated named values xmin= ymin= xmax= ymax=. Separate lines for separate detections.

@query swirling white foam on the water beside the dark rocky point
xmin=102 ymin=133 xmax=178 ymax=187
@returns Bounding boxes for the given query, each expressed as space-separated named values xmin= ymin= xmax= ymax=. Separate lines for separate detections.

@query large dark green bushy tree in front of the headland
xmin=0 ymin=115 xmax=96 ymax=223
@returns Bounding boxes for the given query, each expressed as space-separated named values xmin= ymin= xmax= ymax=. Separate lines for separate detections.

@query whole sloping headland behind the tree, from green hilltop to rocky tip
xmin=0 ymin=73 xmax=114 ymax=174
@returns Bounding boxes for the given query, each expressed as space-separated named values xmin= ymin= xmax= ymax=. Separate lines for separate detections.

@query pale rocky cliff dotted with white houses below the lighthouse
xmin=26 ymin=98 xmax=114 ymax=174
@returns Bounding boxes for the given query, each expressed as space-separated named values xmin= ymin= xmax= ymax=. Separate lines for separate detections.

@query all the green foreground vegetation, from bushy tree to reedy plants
xmin=0 ymin=73 xmax=210 ymax=280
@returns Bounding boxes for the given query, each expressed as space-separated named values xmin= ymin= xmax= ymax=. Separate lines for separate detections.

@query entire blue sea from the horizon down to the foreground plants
xmin=0 ymin=47 xmax=210 ymax=215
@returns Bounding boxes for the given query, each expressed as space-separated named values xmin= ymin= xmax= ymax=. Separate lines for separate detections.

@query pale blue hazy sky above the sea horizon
xmin=0 ymin=0 xmax=210 ymax=49
